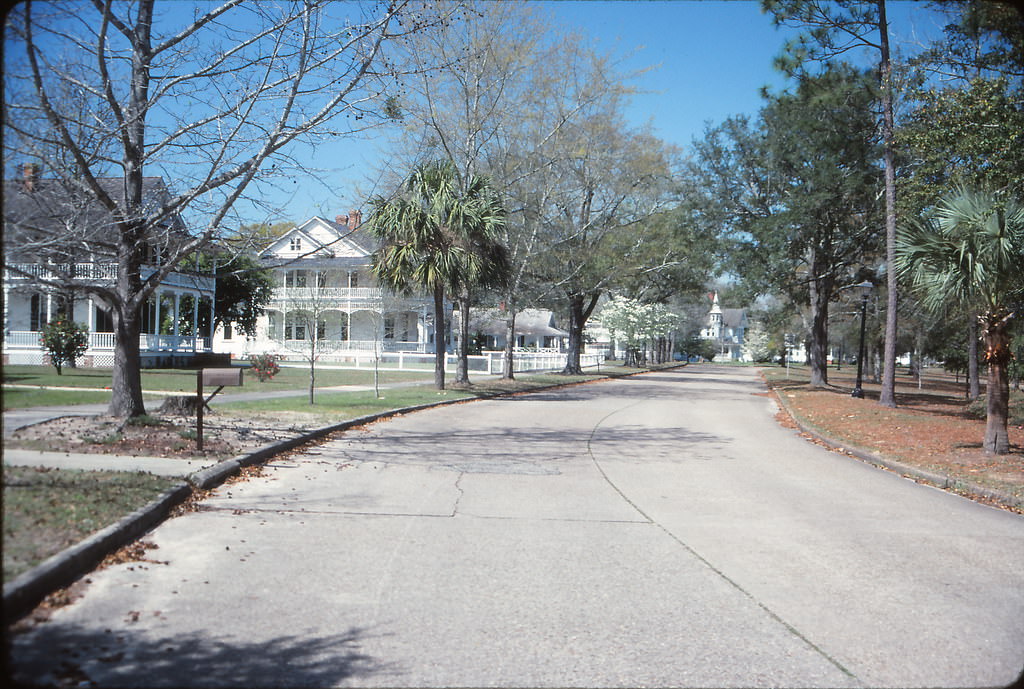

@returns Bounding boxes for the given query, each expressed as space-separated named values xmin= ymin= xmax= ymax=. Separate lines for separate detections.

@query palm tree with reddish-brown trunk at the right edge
xmin=897 ymin=188 xmax=1024 ymax=455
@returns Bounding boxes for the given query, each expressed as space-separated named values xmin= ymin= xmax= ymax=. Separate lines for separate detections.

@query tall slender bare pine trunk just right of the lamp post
xmin=878 ymin=0 xmax=899 ymax=407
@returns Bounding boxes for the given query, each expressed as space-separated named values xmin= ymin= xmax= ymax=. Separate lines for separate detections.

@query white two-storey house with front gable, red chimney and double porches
xmin=217 ymin=211 xmax=442 ymax=361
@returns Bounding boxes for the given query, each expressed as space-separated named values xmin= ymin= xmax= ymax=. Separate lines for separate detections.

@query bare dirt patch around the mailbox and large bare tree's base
xmin=4 ymin=412 xmax=324 ymax=459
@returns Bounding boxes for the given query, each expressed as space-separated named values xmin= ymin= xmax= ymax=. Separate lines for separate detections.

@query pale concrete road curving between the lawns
xmin=12 ymin=365 xmax=1024 ymax=687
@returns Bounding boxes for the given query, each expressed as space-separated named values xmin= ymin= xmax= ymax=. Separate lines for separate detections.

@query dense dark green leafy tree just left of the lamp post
xmin=691 ymin=64 xmax=879 ymax=386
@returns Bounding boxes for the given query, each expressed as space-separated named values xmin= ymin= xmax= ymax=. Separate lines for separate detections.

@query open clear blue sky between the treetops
xmin=251 ymin=0 xmax=942 ymax=222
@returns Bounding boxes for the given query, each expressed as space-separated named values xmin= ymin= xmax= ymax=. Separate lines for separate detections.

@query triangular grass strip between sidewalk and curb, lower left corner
xmin=3 ymin=466 xmax=177 ymax=582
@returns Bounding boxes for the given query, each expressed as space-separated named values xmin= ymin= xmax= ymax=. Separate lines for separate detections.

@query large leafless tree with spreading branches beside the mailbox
xmin=4 ymin=0 xmax=423 ymax=417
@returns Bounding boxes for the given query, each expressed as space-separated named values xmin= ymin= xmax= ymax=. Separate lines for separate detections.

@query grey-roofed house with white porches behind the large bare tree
xmin=3 ymin=165 xmax=216 ymax=367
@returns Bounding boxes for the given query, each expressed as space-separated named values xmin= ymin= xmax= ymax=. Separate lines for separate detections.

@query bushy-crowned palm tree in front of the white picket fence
xmin=369 ymin=161 xmax=507 ymax=390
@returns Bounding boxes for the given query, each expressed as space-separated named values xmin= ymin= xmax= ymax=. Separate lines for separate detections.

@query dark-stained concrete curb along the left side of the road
xmin=3 ymin=364 xmax=685 ymax=625
